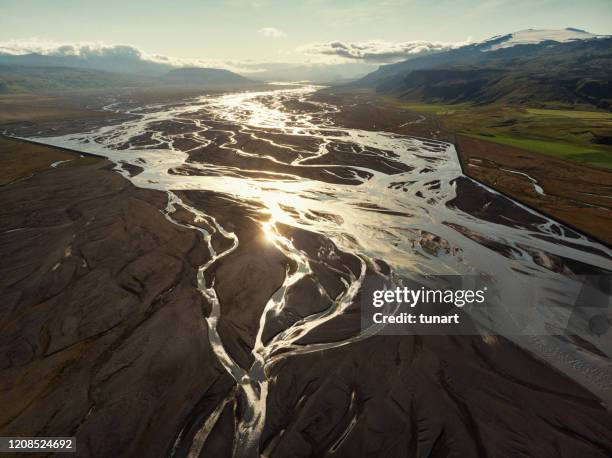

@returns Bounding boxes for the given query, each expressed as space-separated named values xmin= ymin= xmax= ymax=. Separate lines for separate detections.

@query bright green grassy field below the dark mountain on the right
xmin=396 ymin=102 xmax=612 ymax=168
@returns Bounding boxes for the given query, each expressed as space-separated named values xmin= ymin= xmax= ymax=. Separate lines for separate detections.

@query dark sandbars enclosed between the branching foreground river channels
xmin=173 ymin=191 xmax=376 ymax=368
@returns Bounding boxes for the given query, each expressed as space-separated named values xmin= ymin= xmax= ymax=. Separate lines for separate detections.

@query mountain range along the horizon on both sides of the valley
xmin=0 ymin=28 xmax=612 ymax=103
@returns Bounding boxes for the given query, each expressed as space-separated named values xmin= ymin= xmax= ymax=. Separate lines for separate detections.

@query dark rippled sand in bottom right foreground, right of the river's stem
xmin=262 ymin=336 xmax=612 ymax=457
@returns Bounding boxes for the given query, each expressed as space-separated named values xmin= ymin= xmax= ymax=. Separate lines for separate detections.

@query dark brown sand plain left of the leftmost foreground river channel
xmin=0 ymin=151 xmax=233 ymax=457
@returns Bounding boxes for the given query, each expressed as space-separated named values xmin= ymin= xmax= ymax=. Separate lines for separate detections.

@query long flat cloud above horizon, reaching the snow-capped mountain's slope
xmin=298 ymin=40 xmax=469 ymax=63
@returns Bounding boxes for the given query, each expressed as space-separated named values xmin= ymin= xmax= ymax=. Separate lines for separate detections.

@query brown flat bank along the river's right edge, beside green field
xmin=315 ymin=90 xmax=612 ymax=245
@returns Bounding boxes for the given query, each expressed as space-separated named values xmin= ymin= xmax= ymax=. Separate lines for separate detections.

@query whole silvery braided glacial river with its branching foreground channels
xmin=15 ymin=85 xmax=612 ymax=456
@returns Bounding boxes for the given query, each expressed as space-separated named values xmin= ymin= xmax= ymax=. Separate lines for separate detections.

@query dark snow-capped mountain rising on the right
xmin=351 ymin=29 xmax=612 ymax=108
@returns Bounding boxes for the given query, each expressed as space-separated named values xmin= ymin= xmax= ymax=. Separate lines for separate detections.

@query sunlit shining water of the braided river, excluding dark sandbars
xmin=16 ymin=85 xmax=612 ymax=456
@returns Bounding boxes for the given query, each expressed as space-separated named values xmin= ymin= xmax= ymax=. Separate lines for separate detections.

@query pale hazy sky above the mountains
xmin=0 ymin=0 xmax=612 ymax=70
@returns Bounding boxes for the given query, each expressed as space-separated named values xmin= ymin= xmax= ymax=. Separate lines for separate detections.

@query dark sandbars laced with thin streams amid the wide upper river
xmin=163 ymin=111 xmax=412 ymax=185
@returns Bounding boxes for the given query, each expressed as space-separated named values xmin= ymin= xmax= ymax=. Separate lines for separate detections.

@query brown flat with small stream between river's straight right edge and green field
xmin=455 ymin=135 xmax=612 ymax=244
